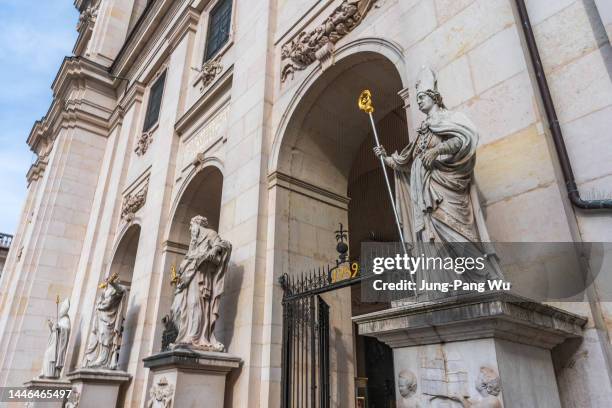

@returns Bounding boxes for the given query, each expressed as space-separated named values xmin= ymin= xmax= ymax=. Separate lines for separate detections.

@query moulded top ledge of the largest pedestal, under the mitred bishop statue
xmin=353 ymin=292 xmax=587 ymax=349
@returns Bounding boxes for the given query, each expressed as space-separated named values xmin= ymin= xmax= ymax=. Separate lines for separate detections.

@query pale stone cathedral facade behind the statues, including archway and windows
xmin=0 ymin=0 xmax=612 ymax=407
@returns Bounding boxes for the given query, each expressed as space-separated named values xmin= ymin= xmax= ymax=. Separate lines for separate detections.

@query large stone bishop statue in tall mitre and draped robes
xmin=374 ymin=68 xmax=502 ymax=288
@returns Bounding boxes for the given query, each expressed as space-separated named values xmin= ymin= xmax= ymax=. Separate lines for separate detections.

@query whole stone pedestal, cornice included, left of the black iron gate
xmin=143 ymin=349 xmax=242 ymax=408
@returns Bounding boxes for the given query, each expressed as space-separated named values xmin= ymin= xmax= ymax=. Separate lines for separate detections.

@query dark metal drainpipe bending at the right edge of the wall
xmin=515 ymin=0 xmax=612 ymax=210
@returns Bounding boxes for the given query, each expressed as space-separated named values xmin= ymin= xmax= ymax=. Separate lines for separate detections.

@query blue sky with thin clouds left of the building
xmin=0 ymin=0 xmax=79 ymax=234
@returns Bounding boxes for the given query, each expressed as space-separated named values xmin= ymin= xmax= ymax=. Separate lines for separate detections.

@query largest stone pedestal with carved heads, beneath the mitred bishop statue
xmin=353 ymin=293 xmax=586 ymax=408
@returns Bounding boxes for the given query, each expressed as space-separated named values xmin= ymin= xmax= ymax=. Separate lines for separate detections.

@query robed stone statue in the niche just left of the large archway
xmin=170 ymin=215 xmax=232 ymax=351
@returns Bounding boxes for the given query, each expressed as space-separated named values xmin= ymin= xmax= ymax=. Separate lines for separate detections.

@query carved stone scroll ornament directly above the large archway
xmin=281 ymin=0 xmax=377 ymax=82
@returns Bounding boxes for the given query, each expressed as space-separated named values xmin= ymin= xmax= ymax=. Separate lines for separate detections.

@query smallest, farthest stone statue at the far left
xmin=40 ymin=296 xmax=70 ymax=378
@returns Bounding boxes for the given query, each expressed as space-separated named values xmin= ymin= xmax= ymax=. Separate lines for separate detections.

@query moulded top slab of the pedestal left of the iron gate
xmin=142 ymin=349 xmax=242 ymax=373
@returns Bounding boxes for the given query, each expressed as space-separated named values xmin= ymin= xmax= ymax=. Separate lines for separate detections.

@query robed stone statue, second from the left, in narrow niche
xmin=83 ymin=273 xmax=128 ymax=370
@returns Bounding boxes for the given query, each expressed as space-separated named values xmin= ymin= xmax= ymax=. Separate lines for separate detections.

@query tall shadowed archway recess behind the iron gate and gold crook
xmin=269 ymin=51 xmax=408 ymax=406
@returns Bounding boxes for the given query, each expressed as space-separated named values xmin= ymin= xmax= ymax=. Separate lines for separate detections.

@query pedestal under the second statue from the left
xmin=67 ymin=368 xmax=132 ymax=407
